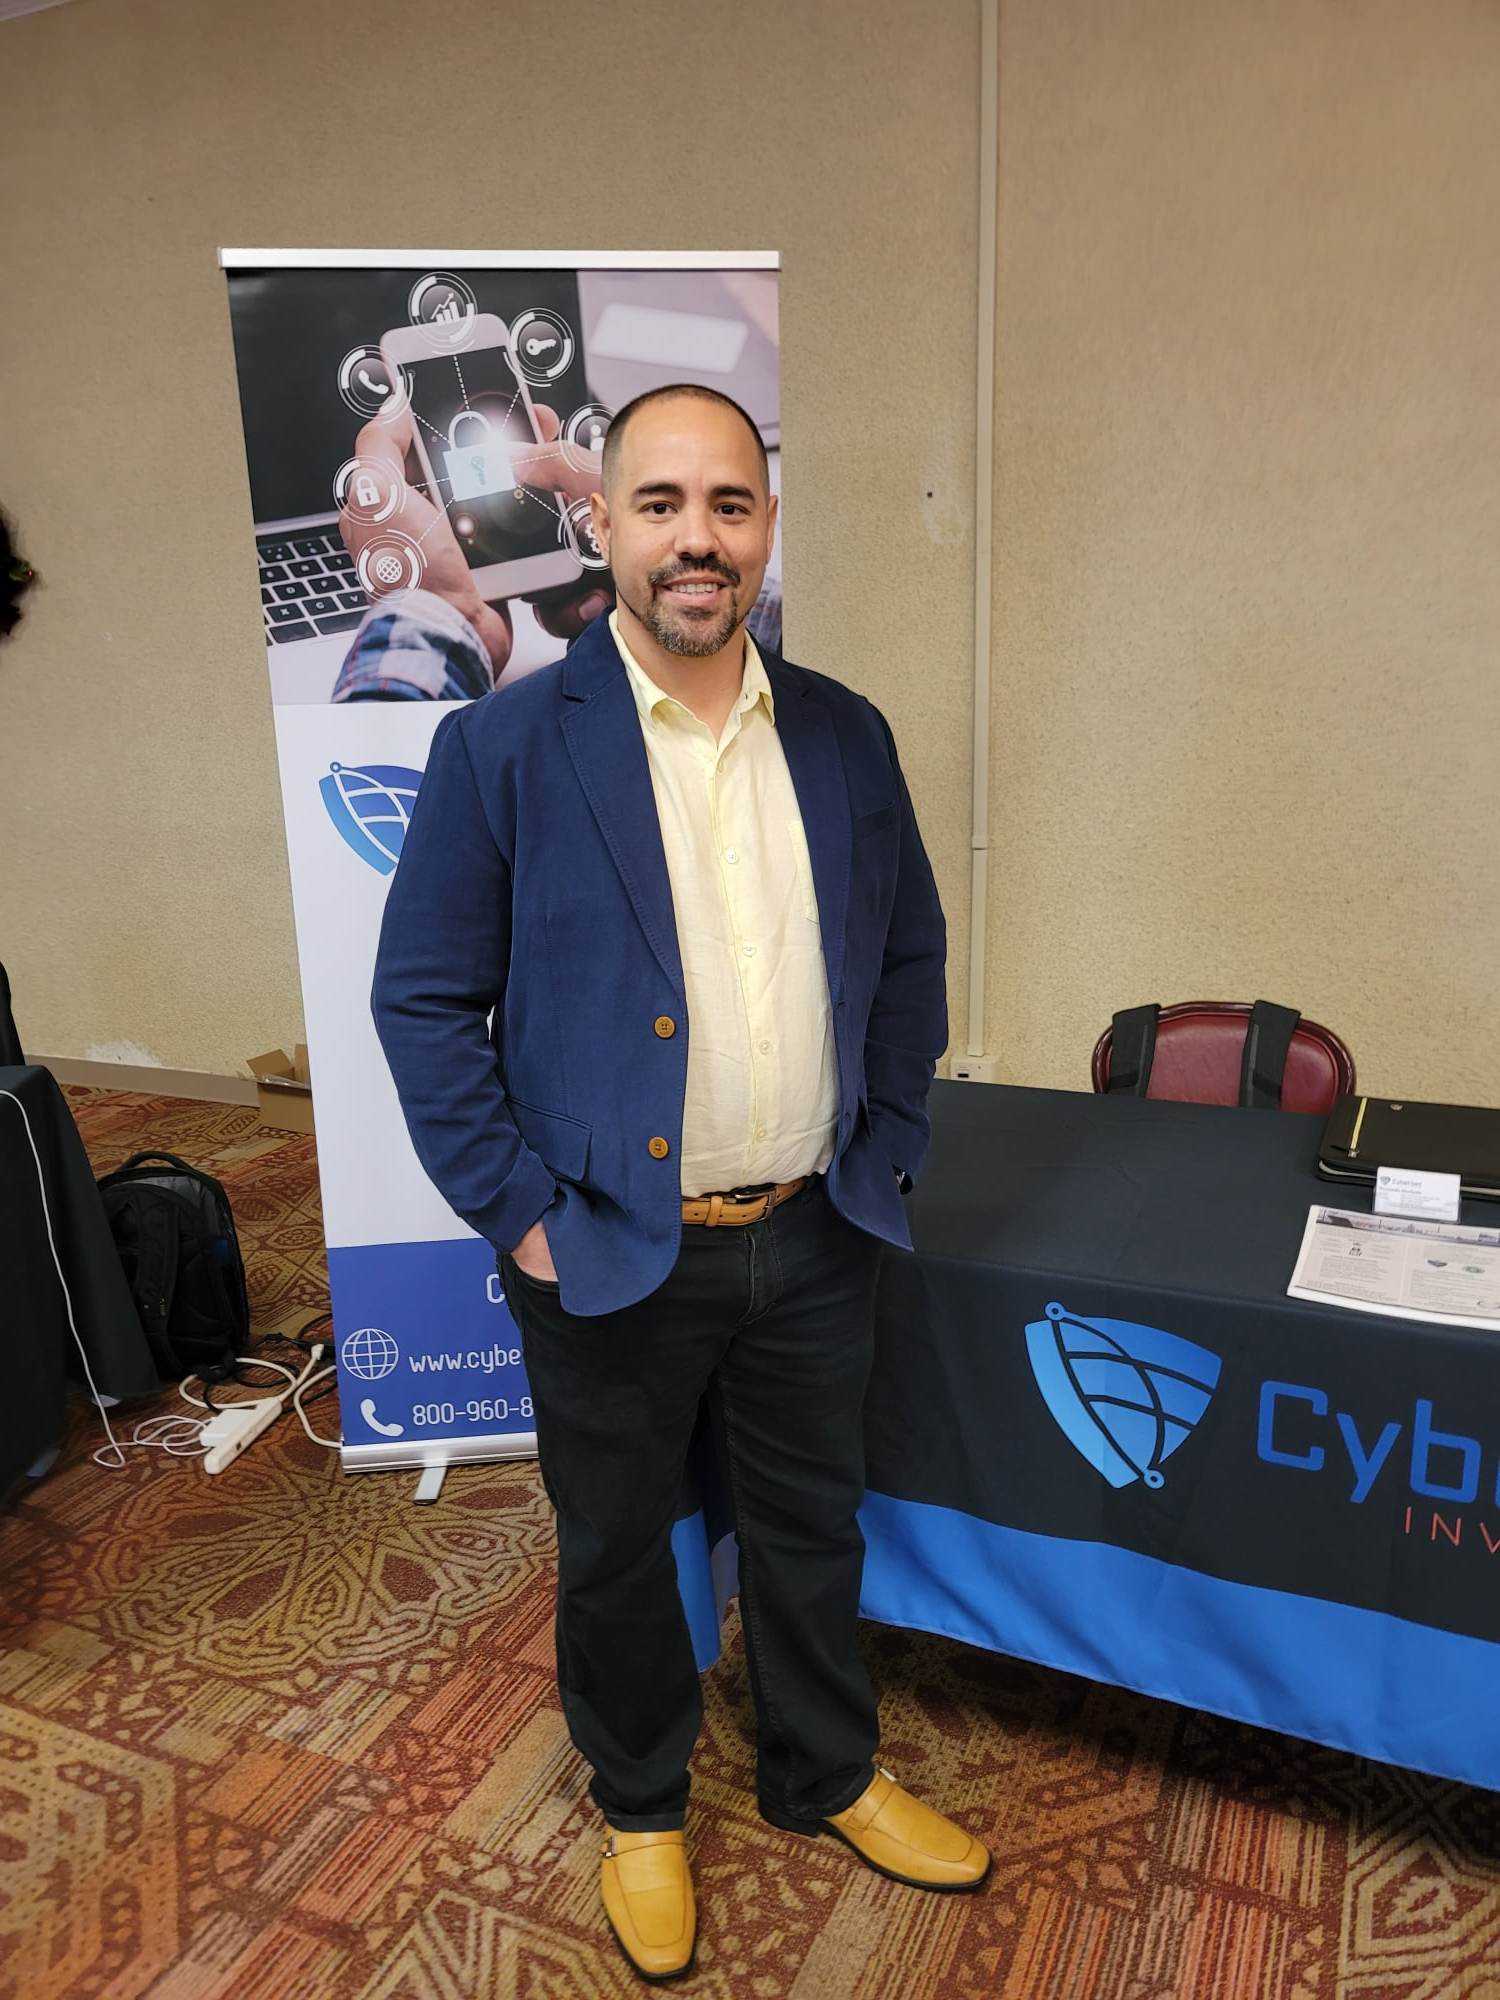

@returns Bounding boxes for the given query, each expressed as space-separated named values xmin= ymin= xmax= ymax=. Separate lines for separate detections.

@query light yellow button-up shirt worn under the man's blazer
xmin=610 ymin=612 xmax=838 ymax=1196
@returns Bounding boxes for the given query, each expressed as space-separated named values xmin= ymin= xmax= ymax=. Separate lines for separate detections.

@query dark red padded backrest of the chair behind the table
xmin=1094 ymin=1000 xmax=1354 ymax=1112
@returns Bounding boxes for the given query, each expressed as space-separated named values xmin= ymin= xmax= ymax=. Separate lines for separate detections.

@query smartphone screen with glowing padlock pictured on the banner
xmin=402 ymin=346 xmax=568 ymax=570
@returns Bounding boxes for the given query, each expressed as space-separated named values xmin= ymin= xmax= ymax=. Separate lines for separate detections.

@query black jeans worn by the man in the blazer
xmin=500 ymin=1174 xmax=882 ymax=1830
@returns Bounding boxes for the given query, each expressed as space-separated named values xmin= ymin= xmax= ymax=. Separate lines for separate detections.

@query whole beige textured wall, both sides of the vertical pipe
xmin=0 ymin=0 xmax=1500 ymax=1102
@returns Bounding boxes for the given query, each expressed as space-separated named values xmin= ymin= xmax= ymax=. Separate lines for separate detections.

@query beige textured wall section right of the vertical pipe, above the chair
xmin=990 ymin=0 xmax=1500 ymax=1104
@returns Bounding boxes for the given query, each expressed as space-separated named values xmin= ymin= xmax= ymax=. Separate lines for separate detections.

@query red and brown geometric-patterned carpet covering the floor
xmin=0 ymin=1090 xmax=1500 ymax=2000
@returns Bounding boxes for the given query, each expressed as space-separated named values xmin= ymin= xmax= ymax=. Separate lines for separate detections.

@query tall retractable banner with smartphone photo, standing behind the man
xmin=218 ymin=250 xmax=782 ymax=1470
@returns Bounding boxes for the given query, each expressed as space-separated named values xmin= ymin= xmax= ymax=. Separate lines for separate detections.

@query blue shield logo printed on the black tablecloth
xmin=1026 ymin=1302 xmax=1220 ymax=1486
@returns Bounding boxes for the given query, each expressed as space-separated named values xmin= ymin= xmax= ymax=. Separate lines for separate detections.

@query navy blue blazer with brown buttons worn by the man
xmin=372 ymin=618 xmax=948 ymax=1314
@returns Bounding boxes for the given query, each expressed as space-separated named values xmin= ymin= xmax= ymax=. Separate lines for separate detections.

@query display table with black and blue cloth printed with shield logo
xmin=678 ymin=1082 xmax=1500 ymax=1788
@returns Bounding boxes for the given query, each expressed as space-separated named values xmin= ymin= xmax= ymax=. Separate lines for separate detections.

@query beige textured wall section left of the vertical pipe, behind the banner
xmin=0 ymin=0 xmax=978 ymax=1072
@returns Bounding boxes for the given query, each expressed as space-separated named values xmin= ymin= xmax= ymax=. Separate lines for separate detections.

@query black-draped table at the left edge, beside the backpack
xmin=0 ymin=1066 xmax=160 ymax=1494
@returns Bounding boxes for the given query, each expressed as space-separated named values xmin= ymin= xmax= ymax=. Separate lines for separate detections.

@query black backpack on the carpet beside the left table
xmin=98 ymin=1152 xmax=250 ymax=1382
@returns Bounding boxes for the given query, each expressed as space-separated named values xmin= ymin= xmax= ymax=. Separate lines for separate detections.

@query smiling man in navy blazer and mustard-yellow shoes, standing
xmin=374 ymin=386 xmax=990 ymax=1980
